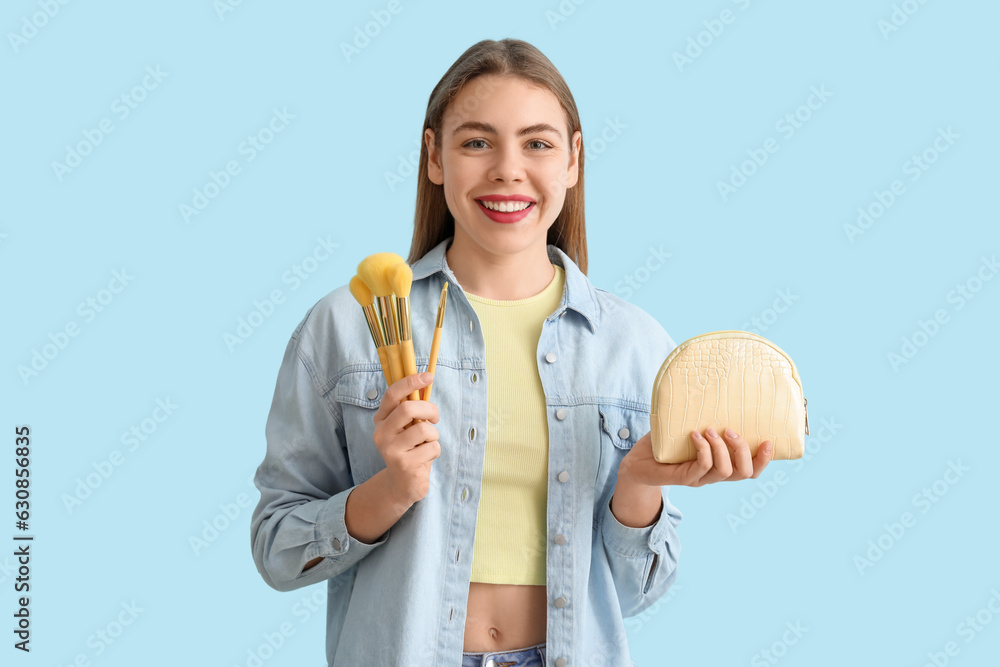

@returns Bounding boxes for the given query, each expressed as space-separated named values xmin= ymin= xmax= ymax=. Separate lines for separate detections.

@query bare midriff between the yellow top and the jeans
xmin=462 ymin=581 xmax=546 ymax=653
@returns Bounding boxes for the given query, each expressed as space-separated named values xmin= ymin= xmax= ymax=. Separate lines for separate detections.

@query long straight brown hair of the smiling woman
xmin=406 ymin=39 xmax=587 ymax=275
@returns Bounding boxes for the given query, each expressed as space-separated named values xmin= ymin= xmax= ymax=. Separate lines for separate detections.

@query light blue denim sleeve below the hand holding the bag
xmin=601 ymin=486 xmax=682 ymax=618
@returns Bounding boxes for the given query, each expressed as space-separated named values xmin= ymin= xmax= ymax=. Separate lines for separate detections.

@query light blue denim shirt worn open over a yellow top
xmin=250 ymin=238 xmax=681 ymax=667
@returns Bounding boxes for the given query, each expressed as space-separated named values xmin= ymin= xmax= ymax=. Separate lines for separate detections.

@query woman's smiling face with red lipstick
xmin=424 ymin=75 xmax=581 ymax=264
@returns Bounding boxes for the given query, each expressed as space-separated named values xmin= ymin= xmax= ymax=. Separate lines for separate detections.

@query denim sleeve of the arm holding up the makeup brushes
xmin=250 ymin=324 xmax=389 ymax=591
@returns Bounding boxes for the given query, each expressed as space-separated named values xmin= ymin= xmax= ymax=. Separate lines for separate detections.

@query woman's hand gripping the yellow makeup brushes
xmin=374 ymin=373 xmax=441 ymax=507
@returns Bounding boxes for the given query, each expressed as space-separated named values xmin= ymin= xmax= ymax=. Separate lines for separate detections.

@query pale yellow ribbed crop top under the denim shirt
xmin=466 ymin=264 xmax=565 ymax=585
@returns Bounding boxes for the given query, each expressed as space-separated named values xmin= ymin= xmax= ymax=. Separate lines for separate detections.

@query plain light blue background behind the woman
xmin=0 ymin=0 xmax=1000 ymax=667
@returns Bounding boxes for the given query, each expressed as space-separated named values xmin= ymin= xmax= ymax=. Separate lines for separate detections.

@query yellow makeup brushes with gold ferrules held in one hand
xmin=350 ymin=252 xmax=448 ymax=401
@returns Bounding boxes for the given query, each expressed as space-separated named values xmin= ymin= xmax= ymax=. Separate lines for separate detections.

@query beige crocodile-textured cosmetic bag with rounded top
xmin=649 ymin=330 xmax=809 ymax=463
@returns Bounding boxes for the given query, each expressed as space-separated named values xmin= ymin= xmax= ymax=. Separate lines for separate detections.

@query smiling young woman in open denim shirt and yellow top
xmin=251 ymin=39 xmax=770 ymax=667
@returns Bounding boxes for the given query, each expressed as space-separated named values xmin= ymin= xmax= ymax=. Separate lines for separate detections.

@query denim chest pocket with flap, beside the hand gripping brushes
xmin=333 ymin=370 xmax=385 ymax=484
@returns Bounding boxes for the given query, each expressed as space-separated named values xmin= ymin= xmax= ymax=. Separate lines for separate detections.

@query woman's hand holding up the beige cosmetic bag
xmin=618 ymin=428 xmax=773 ymax=486
